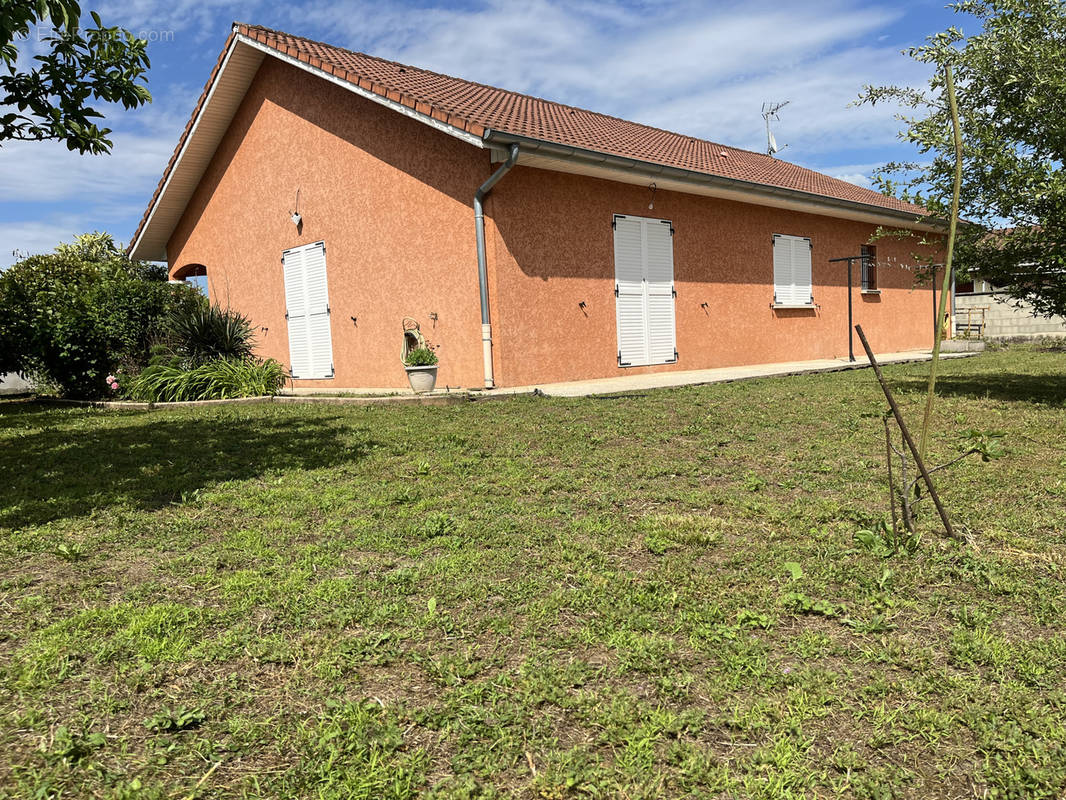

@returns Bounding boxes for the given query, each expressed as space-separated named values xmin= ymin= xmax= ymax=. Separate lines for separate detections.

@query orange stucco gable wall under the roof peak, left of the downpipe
xmin=167 ymin=58 xmax=491 ymax=388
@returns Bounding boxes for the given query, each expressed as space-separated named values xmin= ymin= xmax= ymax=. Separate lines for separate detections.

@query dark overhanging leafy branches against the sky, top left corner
xmin=0 ymin=0 xmax=151 ymax=154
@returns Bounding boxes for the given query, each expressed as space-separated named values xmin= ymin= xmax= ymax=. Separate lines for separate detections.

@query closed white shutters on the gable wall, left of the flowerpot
xmin=281 ymin=242 xmax=334 ymax=379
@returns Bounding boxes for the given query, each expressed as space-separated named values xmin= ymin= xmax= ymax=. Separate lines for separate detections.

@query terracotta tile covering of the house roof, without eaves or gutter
xmin=237 ymin=23 xmax=924 ymax=217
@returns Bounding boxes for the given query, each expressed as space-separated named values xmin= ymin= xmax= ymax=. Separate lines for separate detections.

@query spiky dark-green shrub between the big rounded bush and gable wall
xmin=166 ymin=303 xmax=255 ymax=366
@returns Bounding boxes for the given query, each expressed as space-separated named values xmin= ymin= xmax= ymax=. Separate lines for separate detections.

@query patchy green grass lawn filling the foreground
xmin=0 ymin=347 xmax=1066 ymax=800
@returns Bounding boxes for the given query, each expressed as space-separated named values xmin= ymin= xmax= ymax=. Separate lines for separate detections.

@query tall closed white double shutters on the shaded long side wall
xmin=614 ymin=214 xmax=677 ymax=367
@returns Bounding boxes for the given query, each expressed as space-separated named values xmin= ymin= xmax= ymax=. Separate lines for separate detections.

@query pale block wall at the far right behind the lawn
xmin=954 ymin=281 xmax=1066 ymax=339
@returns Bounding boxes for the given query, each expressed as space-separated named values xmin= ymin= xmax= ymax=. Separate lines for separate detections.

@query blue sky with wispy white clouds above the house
xmin=0 ymin=0 xmax=970 ymax=267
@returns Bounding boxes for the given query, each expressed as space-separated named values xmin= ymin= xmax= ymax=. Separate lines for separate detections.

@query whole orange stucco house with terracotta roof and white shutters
xmin=130 ymin=23 xmax=936 ymax=389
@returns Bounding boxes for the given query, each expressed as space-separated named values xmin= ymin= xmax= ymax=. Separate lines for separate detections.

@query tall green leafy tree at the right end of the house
xmin=860 ymin=0 xmax=1066 ymax=315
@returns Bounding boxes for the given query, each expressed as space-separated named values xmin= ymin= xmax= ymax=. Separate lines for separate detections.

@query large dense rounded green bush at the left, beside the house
xmin=0 ymin=234 xmax=204 ymax=398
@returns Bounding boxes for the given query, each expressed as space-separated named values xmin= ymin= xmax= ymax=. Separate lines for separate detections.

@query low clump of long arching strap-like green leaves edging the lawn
xmin=128 ymin=357 xmax=286 ymax=403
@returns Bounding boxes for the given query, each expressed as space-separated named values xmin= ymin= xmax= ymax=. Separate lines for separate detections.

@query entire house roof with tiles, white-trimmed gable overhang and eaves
xmin=130 ymin=22 xmax=926 ymax=258
